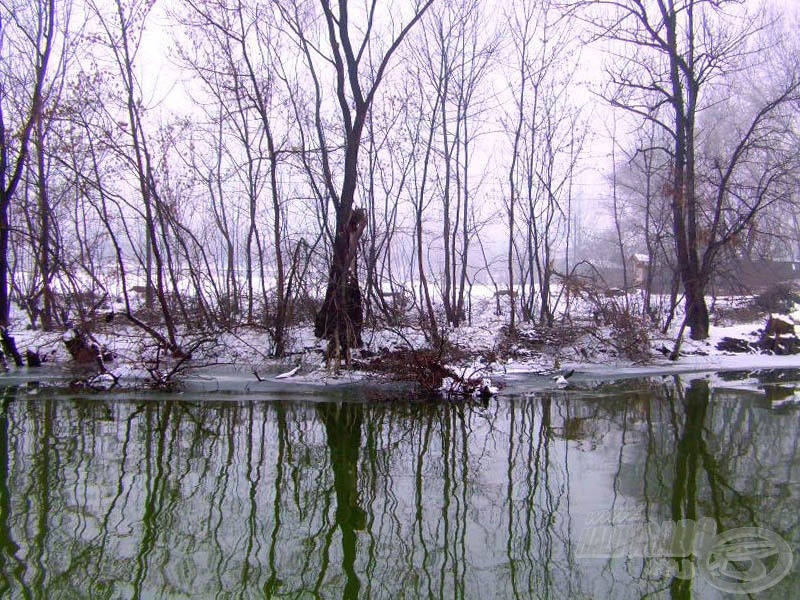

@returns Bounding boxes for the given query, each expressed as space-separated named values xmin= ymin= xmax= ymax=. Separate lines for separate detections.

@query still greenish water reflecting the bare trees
xmin=0 ymin=372 xmax=800 ymax=599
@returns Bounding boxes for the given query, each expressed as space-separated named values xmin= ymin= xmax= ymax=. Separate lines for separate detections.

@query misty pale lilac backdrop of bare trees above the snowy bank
xmin=0 ymin=0 xmax=800 ymax=361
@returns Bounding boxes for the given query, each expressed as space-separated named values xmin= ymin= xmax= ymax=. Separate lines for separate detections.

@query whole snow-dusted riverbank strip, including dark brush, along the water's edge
xmin=5 ymin=292 xmax=800 ymax=393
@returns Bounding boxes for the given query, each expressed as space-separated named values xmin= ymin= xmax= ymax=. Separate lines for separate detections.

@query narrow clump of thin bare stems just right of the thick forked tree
xmin=414 ymin=1 xmax=500 ymax=326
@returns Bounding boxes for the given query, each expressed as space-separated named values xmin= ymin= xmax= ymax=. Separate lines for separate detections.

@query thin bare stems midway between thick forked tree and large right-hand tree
xmin=507 ymin=1 xmax=585 ymax=325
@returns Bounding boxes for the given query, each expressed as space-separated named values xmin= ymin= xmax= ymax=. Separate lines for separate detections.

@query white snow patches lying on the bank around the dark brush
xmin=7 ymin=290 xmax=800 ymax=391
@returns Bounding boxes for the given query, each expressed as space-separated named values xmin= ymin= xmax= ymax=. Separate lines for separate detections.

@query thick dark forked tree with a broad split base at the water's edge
xmin=278 ymin=0 xmax=433 ymax=363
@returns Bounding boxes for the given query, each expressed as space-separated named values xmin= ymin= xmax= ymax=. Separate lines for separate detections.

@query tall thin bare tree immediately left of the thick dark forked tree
xmin=181 ymin=0 xmax=291 ymax=356
